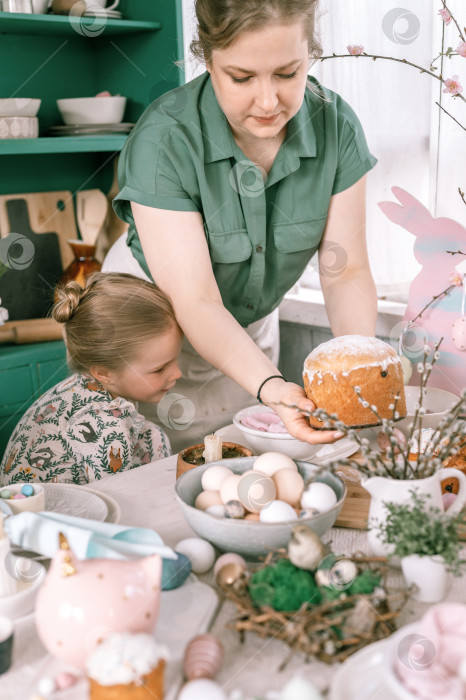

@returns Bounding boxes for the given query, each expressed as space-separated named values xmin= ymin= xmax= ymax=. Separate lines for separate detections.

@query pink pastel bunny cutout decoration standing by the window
xmin=379 ymin=187 xmax=466 ymax=394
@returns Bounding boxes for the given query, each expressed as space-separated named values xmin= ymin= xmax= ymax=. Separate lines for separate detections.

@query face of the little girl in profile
xmin=98 ymin=326 xmax=182 ymax=403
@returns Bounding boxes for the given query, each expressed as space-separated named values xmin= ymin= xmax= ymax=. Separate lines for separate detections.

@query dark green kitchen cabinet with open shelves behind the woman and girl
xmin=0 ymin=0 xmax=184 ymax=456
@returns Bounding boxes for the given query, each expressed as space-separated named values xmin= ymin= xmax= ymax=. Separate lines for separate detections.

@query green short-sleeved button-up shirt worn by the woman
xmin=113 ymin=73 xmax=377 ymax=326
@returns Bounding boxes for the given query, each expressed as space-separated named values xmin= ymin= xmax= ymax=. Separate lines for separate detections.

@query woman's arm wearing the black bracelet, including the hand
xmin=131 ymin=202 xmax=335 ymax=443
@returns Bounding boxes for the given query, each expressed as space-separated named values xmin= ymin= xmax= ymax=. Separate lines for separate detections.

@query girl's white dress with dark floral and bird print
xmin=0 ymin=374 xmax=171 ymax=486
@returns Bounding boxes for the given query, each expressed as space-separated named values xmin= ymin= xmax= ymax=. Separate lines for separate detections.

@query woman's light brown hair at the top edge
xmin=191 ymin=0 xmax=322 ymax=63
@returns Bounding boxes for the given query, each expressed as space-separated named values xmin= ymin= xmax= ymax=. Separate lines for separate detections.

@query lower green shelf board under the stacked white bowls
xmin=0 ymin=134 xmax=128 ymax=155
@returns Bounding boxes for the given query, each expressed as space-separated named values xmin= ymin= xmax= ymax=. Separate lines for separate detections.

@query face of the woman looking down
xmin=207 ymin=22 xmax=309 ymax=141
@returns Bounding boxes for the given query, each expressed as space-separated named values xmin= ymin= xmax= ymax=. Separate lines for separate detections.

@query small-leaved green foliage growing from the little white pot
xmin=377 ymin=491 xmax=466 ymax=576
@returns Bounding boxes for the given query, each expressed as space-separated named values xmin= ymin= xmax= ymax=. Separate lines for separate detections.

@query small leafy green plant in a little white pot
xmin=375 ymin=490 xmax=466 ymax=603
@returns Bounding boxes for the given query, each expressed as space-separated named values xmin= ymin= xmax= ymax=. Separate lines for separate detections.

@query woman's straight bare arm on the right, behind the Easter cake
xmin=319 ymin=176 xmax=377 ymax=336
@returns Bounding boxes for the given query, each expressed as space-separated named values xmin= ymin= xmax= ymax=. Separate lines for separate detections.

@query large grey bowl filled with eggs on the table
xmin=175 ymin=452 xmax=346 ymax=558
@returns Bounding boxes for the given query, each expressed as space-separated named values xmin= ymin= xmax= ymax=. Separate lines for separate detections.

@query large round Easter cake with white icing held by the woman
xmin=303 ymin=335 xmax=406 ymax=429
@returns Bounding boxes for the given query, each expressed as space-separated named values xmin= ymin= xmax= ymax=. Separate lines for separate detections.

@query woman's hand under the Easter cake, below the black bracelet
xmin=261 ymin=379 xmax=343 ymax=445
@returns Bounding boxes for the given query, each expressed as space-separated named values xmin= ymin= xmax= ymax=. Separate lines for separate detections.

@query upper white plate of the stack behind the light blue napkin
xmin=41 ymin=482 xmax=109 ymax=522
